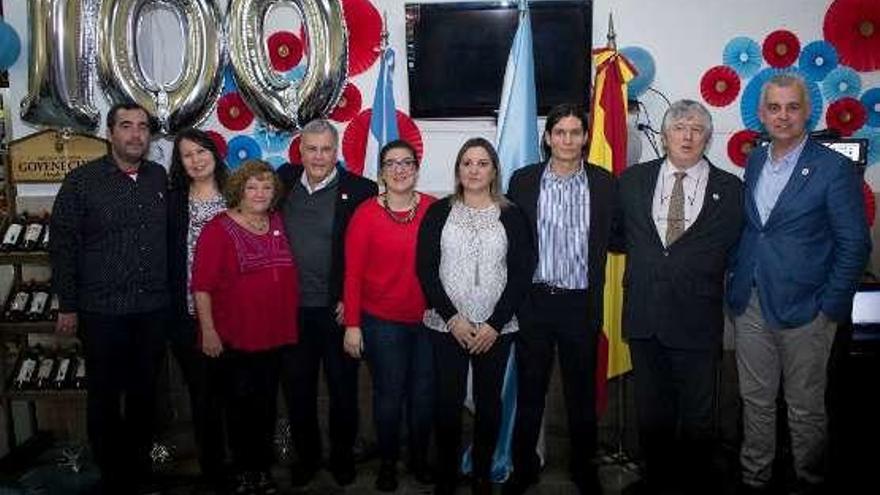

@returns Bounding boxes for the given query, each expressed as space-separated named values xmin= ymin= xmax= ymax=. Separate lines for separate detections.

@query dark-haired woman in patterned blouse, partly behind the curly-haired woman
xmin=167 ymin=129 xmax=229 ymax=488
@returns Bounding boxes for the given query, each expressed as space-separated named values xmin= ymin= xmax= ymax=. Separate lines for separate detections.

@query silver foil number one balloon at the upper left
xmin=21 ymin=0 xmax=99 ymax=131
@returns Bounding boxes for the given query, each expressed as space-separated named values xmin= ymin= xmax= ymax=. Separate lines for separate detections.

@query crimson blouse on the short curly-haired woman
xmin=192 ymin=213 xmax=299 ymax=351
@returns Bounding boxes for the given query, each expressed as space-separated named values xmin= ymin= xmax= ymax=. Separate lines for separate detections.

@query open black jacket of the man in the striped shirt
xmin=507 ymin=162 xmax=615 ymax=331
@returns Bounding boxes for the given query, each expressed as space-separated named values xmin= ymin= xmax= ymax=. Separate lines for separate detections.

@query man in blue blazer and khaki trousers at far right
xmin=727 ymin=74 xmax=871 ymax=493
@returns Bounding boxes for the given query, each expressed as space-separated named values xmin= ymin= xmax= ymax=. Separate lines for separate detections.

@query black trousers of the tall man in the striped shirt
xmin=513 ymin=286 xmax=598 ymax=480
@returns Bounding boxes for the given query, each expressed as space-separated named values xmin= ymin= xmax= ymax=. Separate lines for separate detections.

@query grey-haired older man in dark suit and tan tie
xmin=614 ymin=100 xmax=742 ymax=493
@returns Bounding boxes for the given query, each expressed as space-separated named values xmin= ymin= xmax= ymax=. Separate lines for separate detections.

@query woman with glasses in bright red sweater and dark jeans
xmin=343 ymin=140 xmax=435 ymax=492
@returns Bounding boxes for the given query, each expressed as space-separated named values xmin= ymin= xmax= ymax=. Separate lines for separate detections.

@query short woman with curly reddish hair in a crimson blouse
xmin=192 ymin=160 xmax=299 ymax=495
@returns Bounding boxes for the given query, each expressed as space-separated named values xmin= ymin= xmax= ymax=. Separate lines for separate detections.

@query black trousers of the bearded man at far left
xmin=79 ymin=309 xmax=167 ymax=493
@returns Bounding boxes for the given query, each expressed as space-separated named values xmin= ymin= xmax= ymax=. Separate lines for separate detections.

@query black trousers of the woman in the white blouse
xmin=428 ymin=330 xmax=513 ymax=483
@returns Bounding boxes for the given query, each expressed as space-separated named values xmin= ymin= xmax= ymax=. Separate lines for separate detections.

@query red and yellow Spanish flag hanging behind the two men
xmin=588 ymin=40 xmax=636 ymax=414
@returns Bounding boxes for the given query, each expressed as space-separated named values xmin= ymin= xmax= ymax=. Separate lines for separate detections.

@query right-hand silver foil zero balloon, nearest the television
xmin=227 ymin=0 xmax=348 ymax=130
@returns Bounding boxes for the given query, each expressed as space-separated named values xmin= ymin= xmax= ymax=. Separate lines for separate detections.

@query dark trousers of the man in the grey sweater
xmin=282 ymin=307 xmax=359 ymax=467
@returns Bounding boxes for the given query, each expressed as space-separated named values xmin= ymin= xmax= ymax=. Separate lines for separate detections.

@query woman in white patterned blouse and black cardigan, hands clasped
xmin=417 ymin=138 xmax=534 ymax=494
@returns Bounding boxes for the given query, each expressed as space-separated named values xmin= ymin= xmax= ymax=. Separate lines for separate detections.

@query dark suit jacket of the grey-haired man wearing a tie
xmin=614 ymin=158 xmax=743 ymax=349
